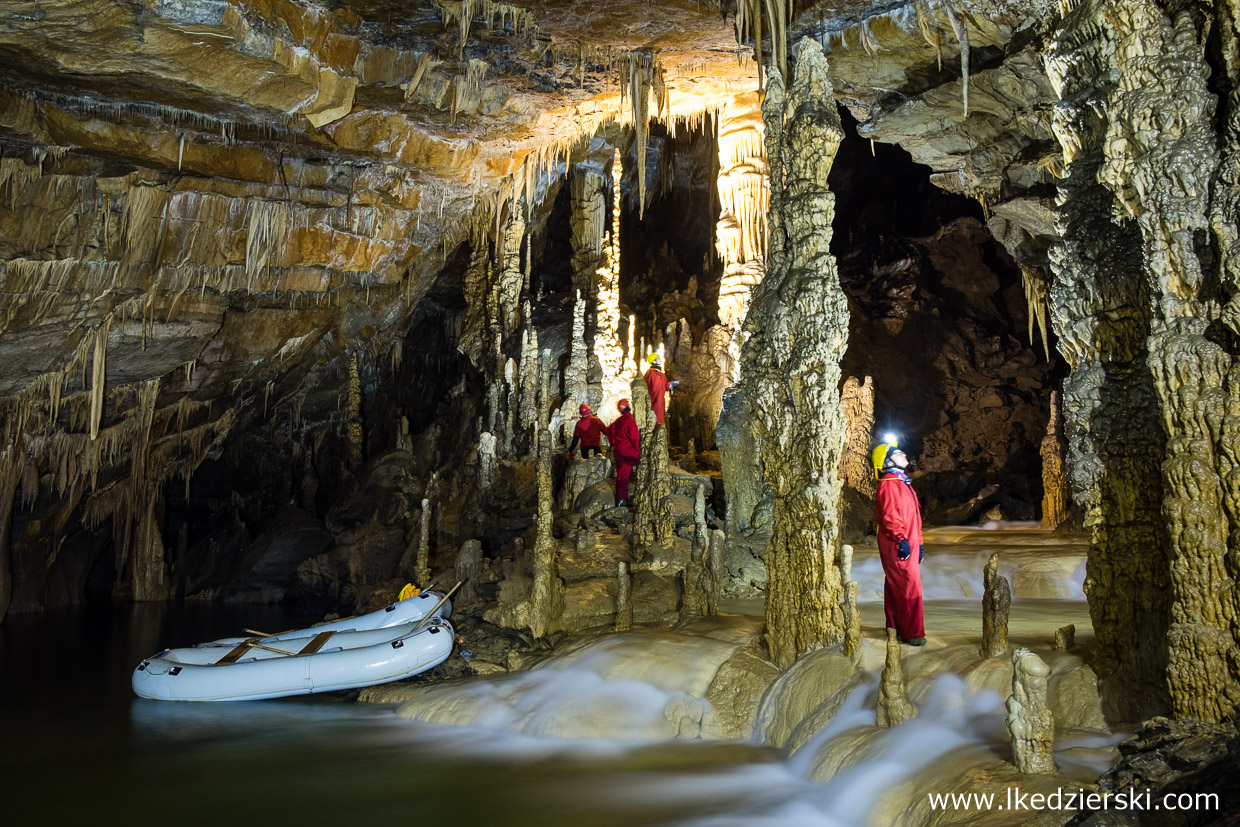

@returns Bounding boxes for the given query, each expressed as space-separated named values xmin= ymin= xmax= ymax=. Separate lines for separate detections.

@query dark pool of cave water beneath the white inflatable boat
xmin=0 ymin=604 xmax=831 ymax=827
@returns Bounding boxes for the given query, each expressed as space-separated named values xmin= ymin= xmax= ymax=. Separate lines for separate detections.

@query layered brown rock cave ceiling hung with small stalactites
xmin=0 ymin=0 xmax=1059 ymax=530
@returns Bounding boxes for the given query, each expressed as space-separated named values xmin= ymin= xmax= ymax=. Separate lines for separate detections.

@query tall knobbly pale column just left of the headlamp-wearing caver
xmin=740 ymin=40 xmax=848 ymax=667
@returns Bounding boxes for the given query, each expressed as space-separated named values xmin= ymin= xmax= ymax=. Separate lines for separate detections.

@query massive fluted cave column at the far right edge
xmin=1047 ymin=0 xmax=1240 ymax=720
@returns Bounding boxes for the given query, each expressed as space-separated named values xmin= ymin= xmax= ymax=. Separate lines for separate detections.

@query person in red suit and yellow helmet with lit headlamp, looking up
xmin=870 ymin=435 xmax=926 ymax=646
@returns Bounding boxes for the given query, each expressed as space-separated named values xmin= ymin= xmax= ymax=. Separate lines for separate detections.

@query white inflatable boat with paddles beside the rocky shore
xmin=131 ymin=594 xmax=455 ymax=701
